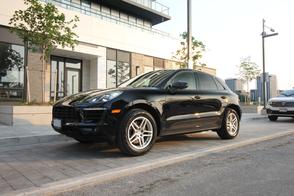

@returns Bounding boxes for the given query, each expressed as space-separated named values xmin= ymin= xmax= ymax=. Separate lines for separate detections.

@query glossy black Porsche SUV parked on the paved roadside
xmin=52 ymin=69 xmax=241 ymax=155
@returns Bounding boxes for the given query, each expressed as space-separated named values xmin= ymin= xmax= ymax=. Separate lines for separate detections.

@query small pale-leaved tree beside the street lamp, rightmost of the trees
xmin=239 ymin=56 xmax=260 ymax=102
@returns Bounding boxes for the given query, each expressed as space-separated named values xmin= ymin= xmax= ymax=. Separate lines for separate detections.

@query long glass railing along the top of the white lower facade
xmin=41 ymin=0 xmax=169 ymax=36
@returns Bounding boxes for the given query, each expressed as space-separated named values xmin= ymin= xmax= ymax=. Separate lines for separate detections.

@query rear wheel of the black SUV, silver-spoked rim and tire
xmin=216 ymin=108 xmax=240 ymax=139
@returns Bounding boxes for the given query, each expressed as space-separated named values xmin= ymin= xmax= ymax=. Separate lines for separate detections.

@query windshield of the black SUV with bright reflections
xmin=119 ymin=70 xmax=175 ymax=88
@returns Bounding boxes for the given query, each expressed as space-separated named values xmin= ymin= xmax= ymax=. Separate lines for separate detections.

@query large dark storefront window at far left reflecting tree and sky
xmin=0 ymin=42 xmax=24 ymax=101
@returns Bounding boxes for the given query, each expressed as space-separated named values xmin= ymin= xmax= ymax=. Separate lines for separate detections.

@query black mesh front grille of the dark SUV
xmin=53 ymin=106 xmax=80 ymax=121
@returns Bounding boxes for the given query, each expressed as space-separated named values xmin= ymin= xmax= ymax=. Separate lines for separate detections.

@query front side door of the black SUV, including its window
xmin=163 ymin=71 xmax=198 ymax=134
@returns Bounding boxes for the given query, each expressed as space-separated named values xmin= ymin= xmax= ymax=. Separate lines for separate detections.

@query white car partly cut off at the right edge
xmin=266 ymin=89 xmax=294 ymax=121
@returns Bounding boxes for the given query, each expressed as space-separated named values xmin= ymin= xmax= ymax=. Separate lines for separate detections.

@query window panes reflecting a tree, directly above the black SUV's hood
xmin=106 ymin=49 xmax=131 ymax=88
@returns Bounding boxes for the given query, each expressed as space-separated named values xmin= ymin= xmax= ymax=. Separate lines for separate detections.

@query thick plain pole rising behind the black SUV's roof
xmin=187 ymin=0 xmax=193 ymax=69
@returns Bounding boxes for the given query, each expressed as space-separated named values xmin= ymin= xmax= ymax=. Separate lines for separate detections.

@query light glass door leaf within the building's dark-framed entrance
xmin=66 ymin=68 xmax=80 ymax=95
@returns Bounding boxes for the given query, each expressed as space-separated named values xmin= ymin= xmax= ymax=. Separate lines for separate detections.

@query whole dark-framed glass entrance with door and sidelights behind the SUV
xmin=50 ymin=56 xmax=82 ymax=99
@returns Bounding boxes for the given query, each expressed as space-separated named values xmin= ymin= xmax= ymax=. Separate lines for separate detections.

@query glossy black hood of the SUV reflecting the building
xmin=55 ymin=88 xmax=122 ymax=106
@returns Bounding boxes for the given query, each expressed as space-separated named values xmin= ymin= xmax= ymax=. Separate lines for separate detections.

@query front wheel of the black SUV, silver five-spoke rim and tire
xmin=117 ymin=109 xmax=157 ymax=156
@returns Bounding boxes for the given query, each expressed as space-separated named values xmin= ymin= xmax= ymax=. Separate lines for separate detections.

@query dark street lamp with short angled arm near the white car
xmin=261 ymin=19 xmax=278 ymax=109
